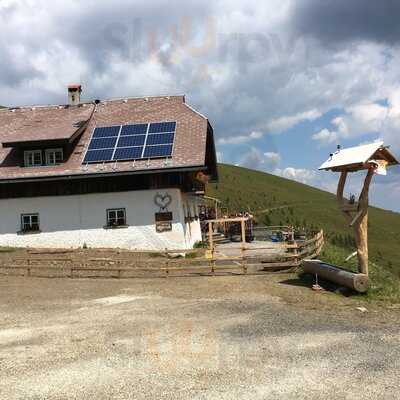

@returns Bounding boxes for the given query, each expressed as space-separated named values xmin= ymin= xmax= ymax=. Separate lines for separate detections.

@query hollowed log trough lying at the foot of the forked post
xmin=303 ymin=260 xmax=369 ymax=293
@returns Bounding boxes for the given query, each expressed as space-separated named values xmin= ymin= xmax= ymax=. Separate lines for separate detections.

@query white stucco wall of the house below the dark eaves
xmin=0 ymin=189 xmax=201 ymax=250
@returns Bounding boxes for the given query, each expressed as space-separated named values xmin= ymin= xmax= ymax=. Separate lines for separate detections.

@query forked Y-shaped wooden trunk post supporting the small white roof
xmin=337 ymin=166 xmax=376 ymax=276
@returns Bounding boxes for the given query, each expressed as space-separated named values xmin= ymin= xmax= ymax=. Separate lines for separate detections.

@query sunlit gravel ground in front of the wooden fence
xmin=0 ymin=275 xmax=400 ymax=400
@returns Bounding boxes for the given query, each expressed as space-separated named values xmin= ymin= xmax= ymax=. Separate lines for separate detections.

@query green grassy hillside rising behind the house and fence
xmin=207 ymin=164 xmax=400 ymax=300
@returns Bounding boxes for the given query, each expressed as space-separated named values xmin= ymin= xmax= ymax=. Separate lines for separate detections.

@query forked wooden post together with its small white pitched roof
xmin=319 ymin=142 xmax=399 ymax=276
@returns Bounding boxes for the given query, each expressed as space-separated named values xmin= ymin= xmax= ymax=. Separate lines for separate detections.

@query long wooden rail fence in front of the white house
xmin=0 ymin=231 xmax=324 ymax=278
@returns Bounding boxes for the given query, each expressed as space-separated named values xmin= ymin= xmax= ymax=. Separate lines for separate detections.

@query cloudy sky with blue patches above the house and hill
xmin=0 ymin=0 xmax=400 ymax=211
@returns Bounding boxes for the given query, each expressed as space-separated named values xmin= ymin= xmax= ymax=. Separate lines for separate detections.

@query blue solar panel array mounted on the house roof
xmin=83 ymin=122 xmax=176 ymax=164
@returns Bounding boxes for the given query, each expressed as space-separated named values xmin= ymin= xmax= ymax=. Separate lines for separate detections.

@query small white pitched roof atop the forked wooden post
xmin=319 ymin=141 xmax=398 ymax=171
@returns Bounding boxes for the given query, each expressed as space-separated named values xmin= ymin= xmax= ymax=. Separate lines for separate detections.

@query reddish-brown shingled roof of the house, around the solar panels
xmin=0 ymin=96 xmax=213 ymax=181
